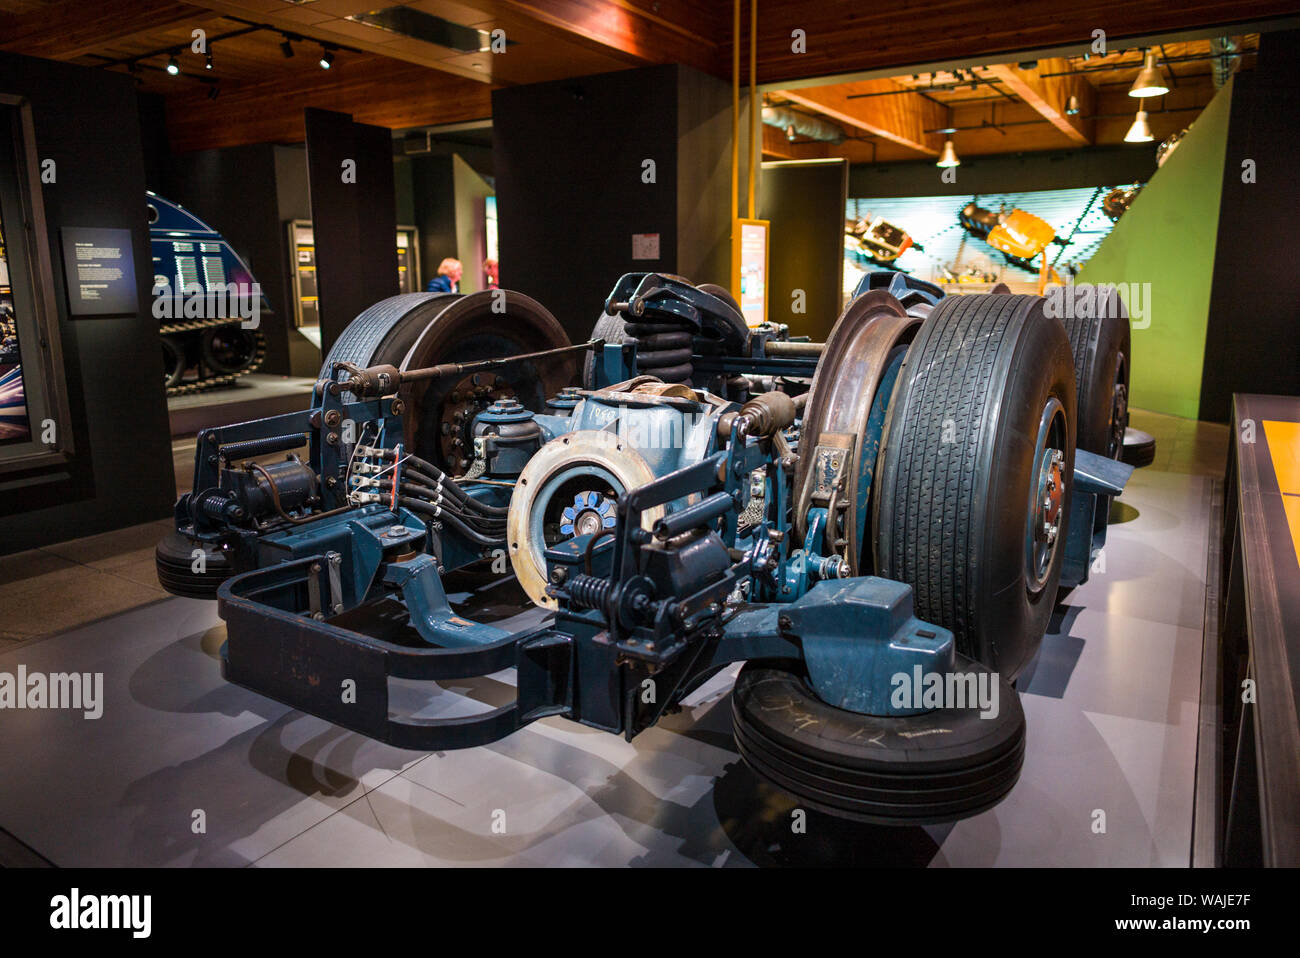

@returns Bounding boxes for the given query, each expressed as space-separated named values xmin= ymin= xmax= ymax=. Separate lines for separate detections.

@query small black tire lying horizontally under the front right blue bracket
xmin=732 ymin=656 xmax=1026 ymax=825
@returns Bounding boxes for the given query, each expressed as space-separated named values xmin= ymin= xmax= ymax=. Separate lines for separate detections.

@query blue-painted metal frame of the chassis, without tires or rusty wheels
xmin=189 ymin=270 xmax=1132 ymax=750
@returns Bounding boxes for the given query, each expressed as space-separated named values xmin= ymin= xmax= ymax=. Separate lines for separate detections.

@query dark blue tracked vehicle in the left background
xmin=147 ymin=192 xmax=270 ymax=395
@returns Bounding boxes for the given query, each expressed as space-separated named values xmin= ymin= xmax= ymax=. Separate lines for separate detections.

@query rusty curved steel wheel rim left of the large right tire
xmin=793 ymin=290 xmax=922 ymax=576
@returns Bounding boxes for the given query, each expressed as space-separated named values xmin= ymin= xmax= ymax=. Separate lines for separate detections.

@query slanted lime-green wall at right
xmin=1076 ymin=74 xmax=1232 ymax=419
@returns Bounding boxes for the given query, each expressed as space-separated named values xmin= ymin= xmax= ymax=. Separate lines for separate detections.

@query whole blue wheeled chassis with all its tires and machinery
xmin=157 ymin=273 xmax=1132 ymax=824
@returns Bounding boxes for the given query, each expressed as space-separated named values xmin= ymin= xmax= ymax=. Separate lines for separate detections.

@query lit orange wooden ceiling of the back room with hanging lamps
xmin=763 ymin=34 xmax=1260 ymax=162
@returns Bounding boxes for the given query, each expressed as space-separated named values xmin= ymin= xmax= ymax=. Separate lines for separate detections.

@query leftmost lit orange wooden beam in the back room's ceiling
xmin=775 ymin=79 xmax=949 ymax=156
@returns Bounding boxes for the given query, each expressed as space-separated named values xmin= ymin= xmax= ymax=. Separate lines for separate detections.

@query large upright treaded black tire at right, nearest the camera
xmin=872 ymin=294 xmax=1075 ymax=680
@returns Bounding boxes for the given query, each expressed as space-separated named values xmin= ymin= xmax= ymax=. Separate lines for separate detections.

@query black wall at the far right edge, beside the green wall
xmin=1199 ymin=31 xmax=1300 ymax=422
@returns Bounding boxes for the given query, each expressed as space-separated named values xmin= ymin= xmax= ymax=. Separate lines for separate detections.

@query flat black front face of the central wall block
xmin=491 ymin=66 xmax=681 ymax=341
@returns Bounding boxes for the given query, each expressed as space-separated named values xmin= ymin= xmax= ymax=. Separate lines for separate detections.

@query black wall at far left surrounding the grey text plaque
xmin=0 ymin=53 xmax=176 ymax=554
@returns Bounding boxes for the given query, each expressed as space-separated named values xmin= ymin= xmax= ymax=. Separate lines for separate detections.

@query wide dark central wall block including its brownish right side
xmin=491 ymin=65 xmax=744 ymax=342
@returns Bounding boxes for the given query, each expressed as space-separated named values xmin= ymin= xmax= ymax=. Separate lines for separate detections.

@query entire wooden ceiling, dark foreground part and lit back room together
xmin=0 ymin=0 xmax=1300 ymax=160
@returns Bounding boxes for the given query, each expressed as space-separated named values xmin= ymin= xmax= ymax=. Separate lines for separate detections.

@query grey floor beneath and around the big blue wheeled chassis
xmin=0 ymin=413 xmax=1227 ymax=866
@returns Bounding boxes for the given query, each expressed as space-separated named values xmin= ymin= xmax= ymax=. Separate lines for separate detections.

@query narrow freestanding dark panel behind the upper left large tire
xmin=304 ymin=108 xmax=398 ymax=354
